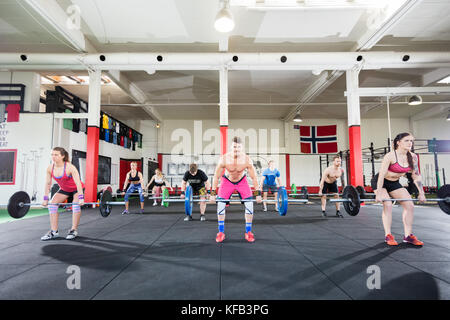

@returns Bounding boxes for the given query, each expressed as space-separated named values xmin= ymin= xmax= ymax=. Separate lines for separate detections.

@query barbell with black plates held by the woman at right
xmin=330 ymin=184 xmax=450 ymax=216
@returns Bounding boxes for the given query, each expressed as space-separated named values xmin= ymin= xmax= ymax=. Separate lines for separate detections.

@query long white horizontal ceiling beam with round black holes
xmin=0 ymin=51 xmax=450 ymax=71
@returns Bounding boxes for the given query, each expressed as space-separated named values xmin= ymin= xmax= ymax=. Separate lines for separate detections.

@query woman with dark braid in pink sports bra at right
xmin=371 ymin=132 xmax=426 ymax=246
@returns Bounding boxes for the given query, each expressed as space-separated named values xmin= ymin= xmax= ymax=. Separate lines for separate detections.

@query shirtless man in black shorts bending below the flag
xmin=319 ymin=155 xmax=345 ymax=218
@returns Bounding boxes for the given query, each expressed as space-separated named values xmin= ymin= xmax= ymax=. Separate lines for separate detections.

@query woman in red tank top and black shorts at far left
xmin=41 ymin=147 xmax=84 ymax=241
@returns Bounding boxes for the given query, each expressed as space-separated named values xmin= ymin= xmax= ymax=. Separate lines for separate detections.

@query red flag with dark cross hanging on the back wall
xmin=294 ymin=125 xmax=337 ymax=153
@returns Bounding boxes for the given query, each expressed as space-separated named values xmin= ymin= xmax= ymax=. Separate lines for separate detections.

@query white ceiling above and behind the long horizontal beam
xmin=0 ymin=0 xmax=450 ymax=120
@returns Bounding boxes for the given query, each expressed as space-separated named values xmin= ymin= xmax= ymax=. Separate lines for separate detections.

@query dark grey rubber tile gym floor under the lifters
xmin=0 ymin=200 xmax=450 ymax=300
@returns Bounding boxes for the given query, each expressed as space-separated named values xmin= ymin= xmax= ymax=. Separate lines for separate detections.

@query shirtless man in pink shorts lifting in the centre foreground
xmin=210 ymin=137 xmax=262 ymax=242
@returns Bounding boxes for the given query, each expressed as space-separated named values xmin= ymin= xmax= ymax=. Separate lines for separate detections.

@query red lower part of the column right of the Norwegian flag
xmin=348 ymin=125 xmax=364 ymax=186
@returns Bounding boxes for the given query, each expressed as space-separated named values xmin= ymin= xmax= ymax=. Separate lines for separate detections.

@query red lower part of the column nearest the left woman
xmin=84 ymin=126 xmax=100 ymax=202
